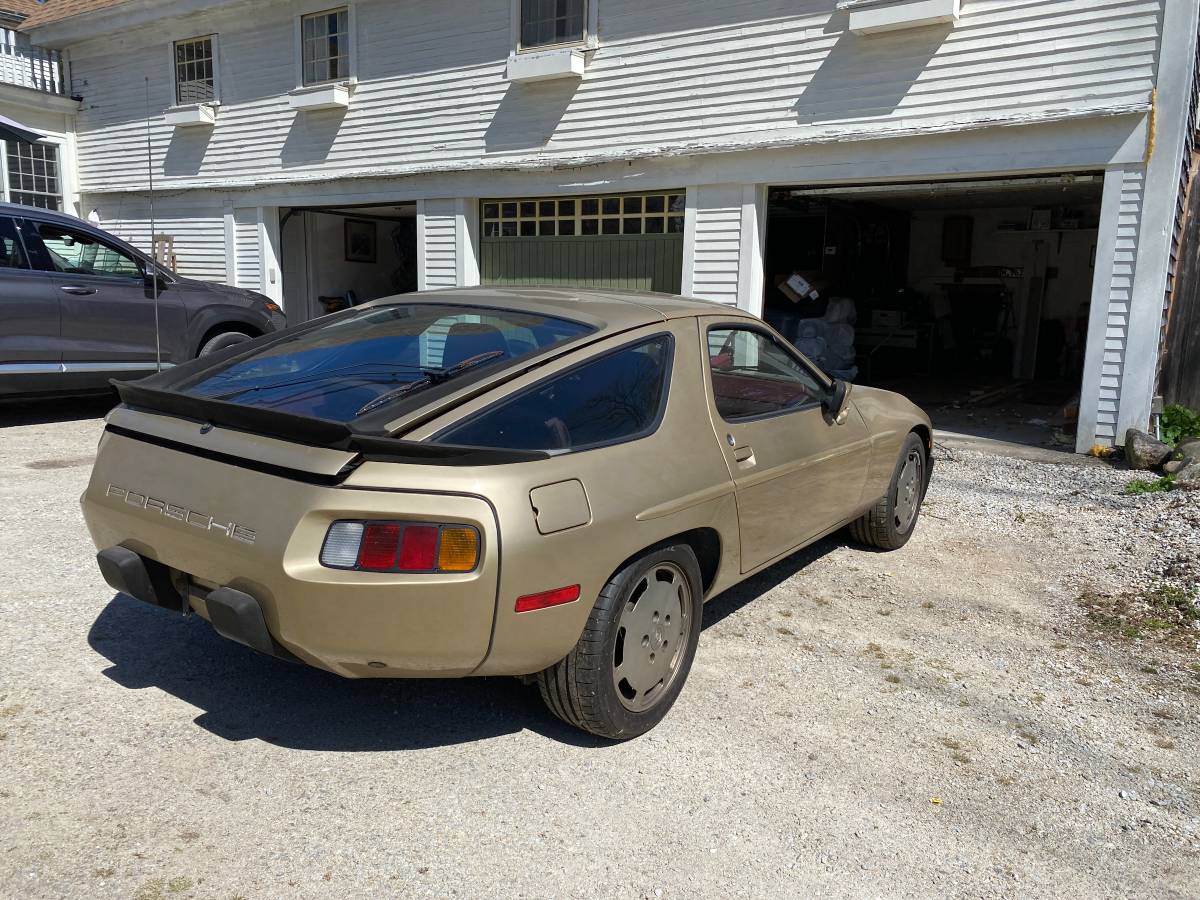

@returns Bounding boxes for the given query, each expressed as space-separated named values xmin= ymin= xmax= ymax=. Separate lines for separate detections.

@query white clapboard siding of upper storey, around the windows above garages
xmin=63 ymin=0 xmax=1166 ymax=191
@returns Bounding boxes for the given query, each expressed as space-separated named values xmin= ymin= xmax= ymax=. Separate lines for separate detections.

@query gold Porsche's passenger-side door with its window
xmin=701 ymin=317 xmax=870 ymax=571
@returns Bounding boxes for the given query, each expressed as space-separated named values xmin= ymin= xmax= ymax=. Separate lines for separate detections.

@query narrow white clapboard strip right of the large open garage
xmin=1096 ymin=167 xmax=1146 ymax=444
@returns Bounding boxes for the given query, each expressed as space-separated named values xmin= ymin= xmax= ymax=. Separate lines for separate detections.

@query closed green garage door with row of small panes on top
xmin=480 ymin=192 xmax=684 ymax=294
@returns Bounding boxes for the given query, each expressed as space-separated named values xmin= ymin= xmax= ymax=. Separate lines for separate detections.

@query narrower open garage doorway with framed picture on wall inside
xmin=280 ymin=204 xmax=416 ymax=324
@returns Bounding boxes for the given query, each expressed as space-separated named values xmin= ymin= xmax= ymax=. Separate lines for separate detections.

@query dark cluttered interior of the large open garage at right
xmin=763 ymin=174 xmax=1103 ymax=450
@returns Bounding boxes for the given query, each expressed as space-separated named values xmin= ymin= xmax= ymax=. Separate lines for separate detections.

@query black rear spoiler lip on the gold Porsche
xmin=110 ymin=379 xmax=551 ymax=466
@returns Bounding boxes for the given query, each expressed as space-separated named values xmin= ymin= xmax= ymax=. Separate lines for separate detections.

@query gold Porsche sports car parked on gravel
xmin=82 ymin=288 xmax=931 ymax=738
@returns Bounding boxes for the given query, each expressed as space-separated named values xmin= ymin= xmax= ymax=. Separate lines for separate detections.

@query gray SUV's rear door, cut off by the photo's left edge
xmin=0 ymin=216 xmax=62 ymax=394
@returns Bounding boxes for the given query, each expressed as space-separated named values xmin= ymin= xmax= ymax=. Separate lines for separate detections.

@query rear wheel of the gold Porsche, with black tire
xmin=538 ymin=545 xmax=703 ymax=740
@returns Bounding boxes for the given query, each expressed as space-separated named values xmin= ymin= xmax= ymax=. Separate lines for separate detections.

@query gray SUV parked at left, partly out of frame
xmin=0 ymin=203 xmax=286 ymax=398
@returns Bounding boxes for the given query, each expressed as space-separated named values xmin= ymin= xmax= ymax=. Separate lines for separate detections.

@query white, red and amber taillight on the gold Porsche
xmin=320 ymin=521 xmax=479 ymax=572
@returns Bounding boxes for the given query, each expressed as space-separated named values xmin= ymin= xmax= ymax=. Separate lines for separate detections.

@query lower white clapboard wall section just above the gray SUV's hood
xmin=96 ymin=197 xmax=228 ymax=282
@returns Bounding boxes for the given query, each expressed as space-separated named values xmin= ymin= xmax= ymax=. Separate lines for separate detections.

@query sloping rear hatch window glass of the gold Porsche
xmin=178 ymin=304 xmax=594 ymax=422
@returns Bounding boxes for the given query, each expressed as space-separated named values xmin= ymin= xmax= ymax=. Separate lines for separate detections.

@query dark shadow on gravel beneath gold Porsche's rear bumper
xmin=88 ymin=594 xmax=612 ymax=752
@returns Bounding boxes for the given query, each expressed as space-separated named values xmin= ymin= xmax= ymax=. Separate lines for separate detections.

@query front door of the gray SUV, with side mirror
xmin=23 ymin=220 xmax=187 ymax=379
